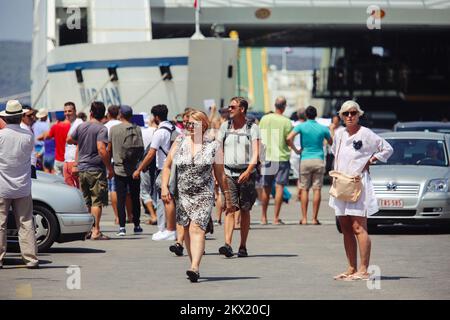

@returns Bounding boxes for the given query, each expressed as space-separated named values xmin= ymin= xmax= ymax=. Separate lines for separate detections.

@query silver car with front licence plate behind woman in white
xmin=368 ymin=132 xmax=450 ymax=227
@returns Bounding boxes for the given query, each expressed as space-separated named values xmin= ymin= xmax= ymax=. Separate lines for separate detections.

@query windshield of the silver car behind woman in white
xmin=378 ymin=139 xmax=448 ymax=167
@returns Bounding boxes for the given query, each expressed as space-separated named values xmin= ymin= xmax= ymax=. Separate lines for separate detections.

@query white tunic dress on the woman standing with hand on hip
xmin=329 ymin=126 xmax=393 ymax=217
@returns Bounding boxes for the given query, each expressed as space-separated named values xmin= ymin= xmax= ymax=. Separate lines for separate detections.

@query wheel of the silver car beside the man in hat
xmin=33 ymin=205 xmax=59 ymax=252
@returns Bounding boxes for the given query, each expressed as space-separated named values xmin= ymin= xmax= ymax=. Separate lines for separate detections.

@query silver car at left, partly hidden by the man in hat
xmin=7 ymin=171 xmax=94 ymax=252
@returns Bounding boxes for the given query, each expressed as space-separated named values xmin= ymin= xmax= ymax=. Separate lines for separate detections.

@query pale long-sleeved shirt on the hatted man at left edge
xmin=0 ymin=124 xmax=34 ymax=199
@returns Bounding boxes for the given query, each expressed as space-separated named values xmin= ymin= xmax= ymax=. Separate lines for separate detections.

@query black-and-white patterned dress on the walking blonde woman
xmin=173 ymin=137 xmax=219 ymax=230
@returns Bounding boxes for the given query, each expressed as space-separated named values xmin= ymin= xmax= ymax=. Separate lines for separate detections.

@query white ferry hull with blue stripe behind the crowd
xmin=31 ymin=0 xmax=238 ymax=117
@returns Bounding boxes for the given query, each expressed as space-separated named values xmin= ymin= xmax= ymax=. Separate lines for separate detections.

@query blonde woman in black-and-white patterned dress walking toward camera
xmin=161 ymin=111 xmax=234 ymax=282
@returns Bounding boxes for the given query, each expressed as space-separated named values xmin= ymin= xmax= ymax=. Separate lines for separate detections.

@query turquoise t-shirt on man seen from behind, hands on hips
xmin=294 ymin=120 xmax=331 ymax=160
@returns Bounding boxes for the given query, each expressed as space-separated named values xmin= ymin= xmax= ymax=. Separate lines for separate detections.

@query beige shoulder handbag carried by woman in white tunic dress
xmin=329 ymin=135 xmax=362 ymax=202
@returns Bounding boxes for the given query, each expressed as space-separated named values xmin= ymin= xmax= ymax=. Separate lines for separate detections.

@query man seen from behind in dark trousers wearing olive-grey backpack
xmin=108 ymin=105 xmax=144 ymax=236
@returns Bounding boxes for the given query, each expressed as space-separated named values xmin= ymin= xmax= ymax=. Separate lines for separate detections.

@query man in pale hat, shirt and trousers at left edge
xmin=0 ymin=100 xmax=39 ymax=269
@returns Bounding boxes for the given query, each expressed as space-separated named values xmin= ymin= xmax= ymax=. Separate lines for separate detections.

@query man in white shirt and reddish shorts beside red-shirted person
xmin=63 ymin=101 xmax=83 ymax=188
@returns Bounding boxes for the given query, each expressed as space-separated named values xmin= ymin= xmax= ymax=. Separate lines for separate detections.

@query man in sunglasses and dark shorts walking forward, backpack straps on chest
xmin=217 ymin=97 xmax=261 ymax=258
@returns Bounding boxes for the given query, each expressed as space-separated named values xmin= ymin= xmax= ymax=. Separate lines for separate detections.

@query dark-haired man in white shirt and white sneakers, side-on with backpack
xmin=133 ymin=104 xmax=178 ymax=241
